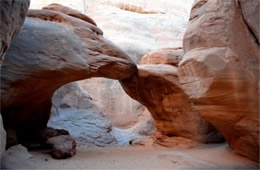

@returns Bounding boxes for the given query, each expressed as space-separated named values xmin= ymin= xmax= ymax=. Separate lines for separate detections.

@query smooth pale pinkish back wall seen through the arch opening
xmin=79 ymin=78 xmax=145 ymax=129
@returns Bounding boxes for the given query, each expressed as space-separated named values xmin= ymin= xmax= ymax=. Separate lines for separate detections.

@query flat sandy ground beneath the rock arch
xmin=2 ymin=144 xmax=258 ymax=170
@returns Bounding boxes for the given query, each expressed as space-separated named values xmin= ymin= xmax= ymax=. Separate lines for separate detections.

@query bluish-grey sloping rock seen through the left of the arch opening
xmin=48 ymin=83 xmax=117 ymax=146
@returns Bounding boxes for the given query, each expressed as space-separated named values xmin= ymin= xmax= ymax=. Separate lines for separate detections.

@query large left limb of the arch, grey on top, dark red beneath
xmin=1 ymin=4 xmax=136 ymax=149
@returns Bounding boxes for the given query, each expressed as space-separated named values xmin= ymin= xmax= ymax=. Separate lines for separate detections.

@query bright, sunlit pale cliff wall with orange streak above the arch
xmin=86 ymin=0 xmax=193 ymax=62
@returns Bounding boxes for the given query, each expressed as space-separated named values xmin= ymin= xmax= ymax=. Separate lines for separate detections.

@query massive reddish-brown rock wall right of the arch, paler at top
xmin=178 ymin=0 xmax=259 ymax=161
